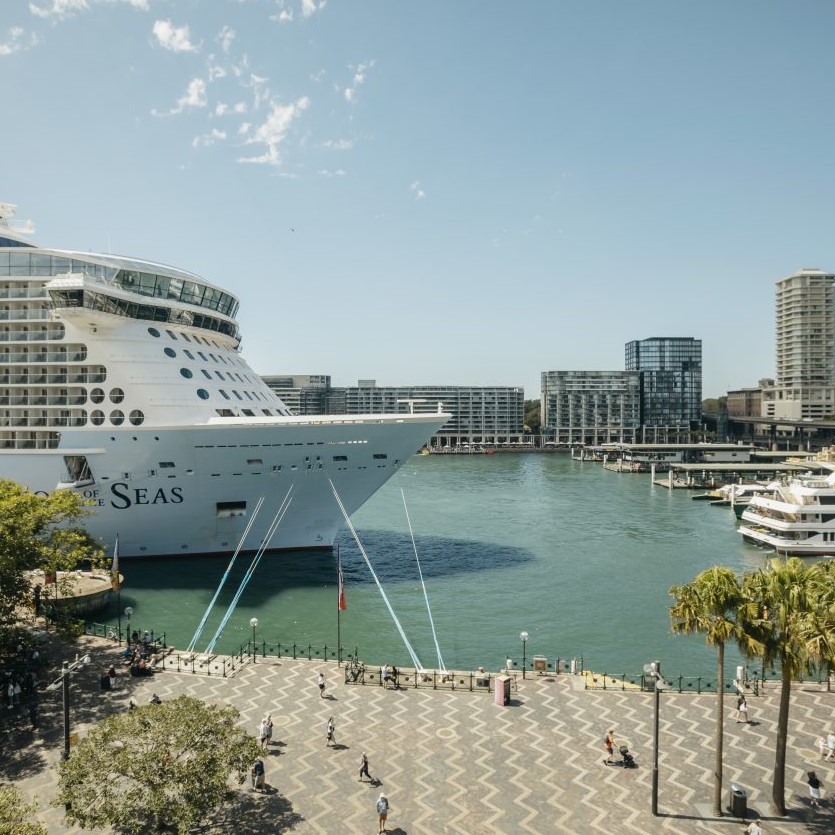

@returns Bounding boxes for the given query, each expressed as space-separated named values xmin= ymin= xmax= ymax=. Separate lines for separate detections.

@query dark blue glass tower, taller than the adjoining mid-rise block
xmin=626 ymin=336 xmax=702 ymax=429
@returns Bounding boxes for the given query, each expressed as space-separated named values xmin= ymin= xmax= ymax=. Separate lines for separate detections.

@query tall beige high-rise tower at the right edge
xmin=762 ymin=269 xmax=835 ymax=420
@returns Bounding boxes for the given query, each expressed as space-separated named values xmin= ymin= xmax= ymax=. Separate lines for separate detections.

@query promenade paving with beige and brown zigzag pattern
xmin=2 ymin=643 xmax=835 ymax=835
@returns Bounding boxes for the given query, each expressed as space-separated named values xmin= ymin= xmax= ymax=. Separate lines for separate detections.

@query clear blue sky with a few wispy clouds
xmin=0 ymin=0 xmax=835 ymax=398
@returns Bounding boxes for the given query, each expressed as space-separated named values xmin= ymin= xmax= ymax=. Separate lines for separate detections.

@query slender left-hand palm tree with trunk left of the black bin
xmin=670 ymin=566 xmax=745 ymax=817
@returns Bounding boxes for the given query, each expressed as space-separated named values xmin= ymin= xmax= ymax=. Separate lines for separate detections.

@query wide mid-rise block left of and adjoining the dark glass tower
xmin=542 ymin=371 xmax=641 ymax=446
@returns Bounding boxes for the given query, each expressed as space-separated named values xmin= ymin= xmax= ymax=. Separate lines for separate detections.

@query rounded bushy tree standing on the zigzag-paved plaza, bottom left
xmin=55 ymin=696 xmax=260 ymax=833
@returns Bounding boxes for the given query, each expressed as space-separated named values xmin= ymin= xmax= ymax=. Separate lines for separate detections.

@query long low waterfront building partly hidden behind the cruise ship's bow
xmin=263 ymin=374 xmax=525 ymax=448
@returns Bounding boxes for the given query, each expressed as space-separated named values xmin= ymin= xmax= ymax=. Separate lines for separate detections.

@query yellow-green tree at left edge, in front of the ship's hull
xmin=0 ymin=480 xmax=102 ymax=627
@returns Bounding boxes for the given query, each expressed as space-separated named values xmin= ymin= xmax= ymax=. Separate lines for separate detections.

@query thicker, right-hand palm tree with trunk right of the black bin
xmin=742 ymin=557 xmax=815 ymax=815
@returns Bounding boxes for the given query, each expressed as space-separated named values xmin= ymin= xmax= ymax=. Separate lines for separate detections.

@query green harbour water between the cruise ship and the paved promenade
xmin=108 ymin=453 xmax=767 ymax=678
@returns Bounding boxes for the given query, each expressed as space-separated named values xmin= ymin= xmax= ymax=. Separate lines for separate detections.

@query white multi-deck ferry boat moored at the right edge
xmin=739 ymin=473 xmax=835 ymax=557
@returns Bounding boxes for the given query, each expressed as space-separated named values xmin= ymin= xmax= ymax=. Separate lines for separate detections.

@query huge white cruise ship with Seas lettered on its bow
xmin=0 ymin=203 xmax=450 ymax=558
